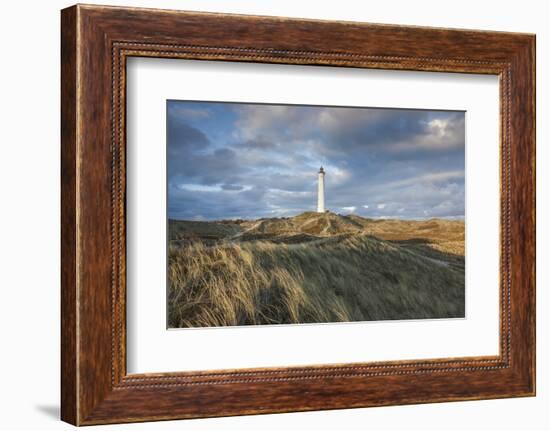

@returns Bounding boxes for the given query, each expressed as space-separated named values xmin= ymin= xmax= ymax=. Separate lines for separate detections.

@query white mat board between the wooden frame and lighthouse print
xmin=127 ymin=58 xmax=500 ymax=373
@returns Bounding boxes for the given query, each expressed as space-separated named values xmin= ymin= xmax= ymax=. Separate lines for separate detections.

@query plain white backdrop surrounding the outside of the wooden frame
xmin=0 ymin=0 xmax=550 ymax=431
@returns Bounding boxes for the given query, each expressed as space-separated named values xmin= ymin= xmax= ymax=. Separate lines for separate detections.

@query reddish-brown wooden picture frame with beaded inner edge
xmin=61 ymin=5 xmax=535 ymax=425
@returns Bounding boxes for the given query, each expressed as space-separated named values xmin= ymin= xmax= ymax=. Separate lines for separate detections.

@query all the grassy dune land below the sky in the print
xmin=168 ymin=213 xmax=464 ymax=327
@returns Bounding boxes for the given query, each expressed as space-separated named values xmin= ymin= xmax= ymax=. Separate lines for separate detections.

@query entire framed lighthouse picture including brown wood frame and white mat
xmin=61 ymin=5 xmax=535 ymax=425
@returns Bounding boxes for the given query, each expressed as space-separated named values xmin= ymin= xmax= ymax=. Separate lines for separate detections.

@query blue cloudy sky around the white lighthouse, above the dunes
xmin=167 ymin=101 xmax=465 ymax=220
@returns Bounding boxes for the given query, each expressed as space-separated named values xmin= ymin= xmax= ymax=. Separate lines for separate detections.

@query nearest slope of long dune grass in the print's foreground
xmin=168 ymin=233 xmax=464 ymax=328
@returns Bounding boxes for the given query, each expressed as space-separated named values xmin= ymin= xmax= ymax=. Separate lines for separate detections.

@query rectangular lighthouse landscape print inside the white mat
xmin=167 ymin=100 xmax=465 ymax=328
